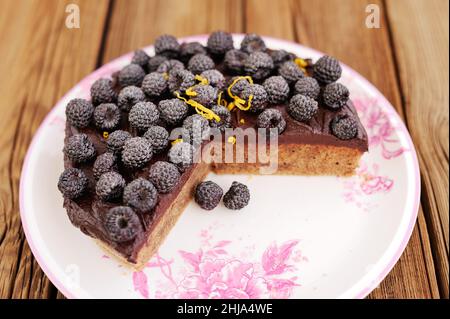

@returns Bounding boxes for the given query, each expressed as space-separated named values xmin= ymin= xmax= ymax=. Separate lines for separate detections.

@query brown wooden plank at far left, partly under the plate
xmin=0 ymin=0 xmax=108 ymax=298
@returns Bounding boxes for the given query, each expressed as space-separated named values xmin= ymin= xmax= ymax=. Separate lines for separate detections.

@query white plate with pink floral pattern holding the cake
xmin=20 ymin=35 xmax=420 ymax=298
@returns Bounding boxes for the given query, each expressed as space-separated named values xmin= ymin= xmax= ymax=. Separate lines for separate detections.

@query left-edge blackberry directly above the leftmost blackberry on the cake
xmin=64 ymin=133 xmax=96 ymax=163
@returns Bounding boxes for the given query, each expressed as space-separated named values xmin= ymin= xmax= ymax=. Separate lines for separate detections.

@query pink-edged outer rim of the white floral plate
xmin=19 ymin=34 xmax=420 ymax=299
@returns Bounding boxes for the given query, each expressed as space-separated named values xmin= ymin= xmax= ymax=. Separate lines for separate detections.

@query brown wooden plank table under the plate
xmin=0 ymin=0 xmax=449 ymax=298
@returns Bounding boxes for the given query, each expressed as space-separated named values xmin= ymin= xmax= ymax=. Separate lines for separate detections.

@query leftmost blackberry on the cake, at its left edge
xmin=58 ymin=167 xmax=88 ymax=199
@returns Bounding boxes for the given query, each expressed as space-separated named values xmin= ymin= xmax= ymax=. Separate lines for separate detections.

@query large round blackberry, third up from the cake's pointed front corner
xmin=122 ymin=137 xmax=153 ymax=169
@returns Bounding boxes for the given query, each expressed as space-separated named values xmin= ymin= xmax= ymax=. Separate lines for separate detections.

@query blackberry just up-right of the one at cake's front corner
xmin=123 ymin=177 xmax=158 ymax=213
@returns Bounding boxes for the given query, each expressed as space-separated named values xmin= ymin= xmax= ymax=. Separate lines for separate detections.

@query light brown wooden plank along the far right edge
xmin=386 ymin=0 xmax=449 ymax=298
